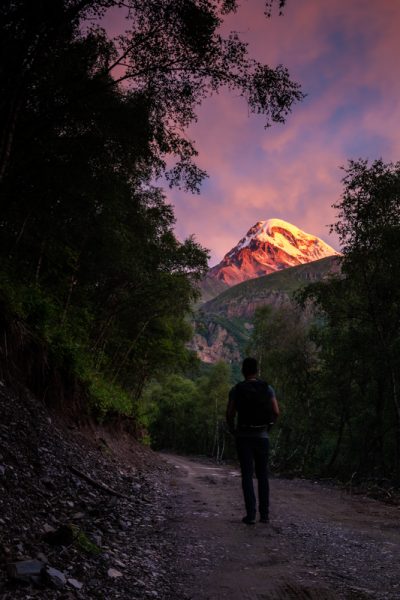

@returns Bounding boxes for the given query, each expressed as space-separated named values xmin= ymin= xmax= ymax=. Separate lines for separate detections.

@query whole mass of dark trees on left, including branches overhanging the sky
xmin=0 ymin=0 xmax=302 ymax=418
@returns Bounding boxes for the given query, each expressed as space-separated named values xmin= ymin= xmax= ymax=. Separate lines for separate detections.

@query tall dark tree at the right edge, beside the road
xmin=304 ymin=160 xmax=400 ymax=476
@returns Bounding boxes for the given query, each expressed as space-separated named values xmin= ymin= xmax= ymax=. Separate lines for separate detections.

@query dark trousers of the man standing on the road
xmin=236 ymin=437 xmax=269 ymax=519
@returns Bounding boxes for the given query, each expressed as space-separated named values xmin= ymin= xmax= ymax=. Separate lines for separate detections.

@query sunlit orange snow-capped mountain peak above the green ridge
xmin=208 ymin=219 xmax=339 ymax=286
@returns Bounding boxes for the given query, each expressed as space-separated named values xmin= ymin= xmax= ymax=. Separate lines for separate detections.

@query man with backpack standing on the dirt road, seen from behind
xmin=226 ymin=358 xmax=279 ymax=525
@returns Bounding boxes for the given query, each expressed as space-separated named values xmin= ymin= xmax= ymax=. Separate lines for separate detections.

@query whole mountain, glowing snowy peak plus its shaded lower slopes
xmin=190 ymin=219 xmax=340 ymax=363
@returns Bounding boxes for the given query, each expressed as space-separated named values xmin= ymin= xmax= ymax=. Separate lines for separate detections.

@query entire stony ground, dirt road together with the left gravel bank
xmin=0 ymin=382 xmax=400 ymax=600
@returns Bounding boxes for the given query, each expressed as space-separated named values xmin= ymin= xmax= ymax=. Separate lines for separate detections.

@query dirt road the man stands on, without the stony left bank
xmin=163 ymin=456 xmax=400 ymax=600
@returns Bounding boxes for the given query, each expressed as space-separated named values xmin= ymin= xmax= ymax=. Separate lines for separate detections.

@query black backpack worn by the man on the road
xmin=235 ymin=379 xmax=273 ymax=429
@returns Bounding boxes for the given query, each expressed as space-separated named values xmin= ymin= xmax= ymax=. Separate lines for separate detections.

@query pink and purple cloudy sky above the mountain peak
xmin=162 ymin=0 xmax=400 ymax=266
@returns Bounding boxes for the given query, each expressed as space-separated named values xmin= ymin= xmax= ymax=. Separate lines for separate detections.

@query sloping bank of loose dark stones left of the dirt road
xmin=0 ymin=382 xmax=179 ymax=600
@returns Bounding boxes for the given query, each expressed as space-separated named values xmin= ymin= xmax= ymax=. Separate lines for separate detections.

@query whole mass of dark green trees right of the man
xmin=247 ymin=160 xmax=400 ymax=479
